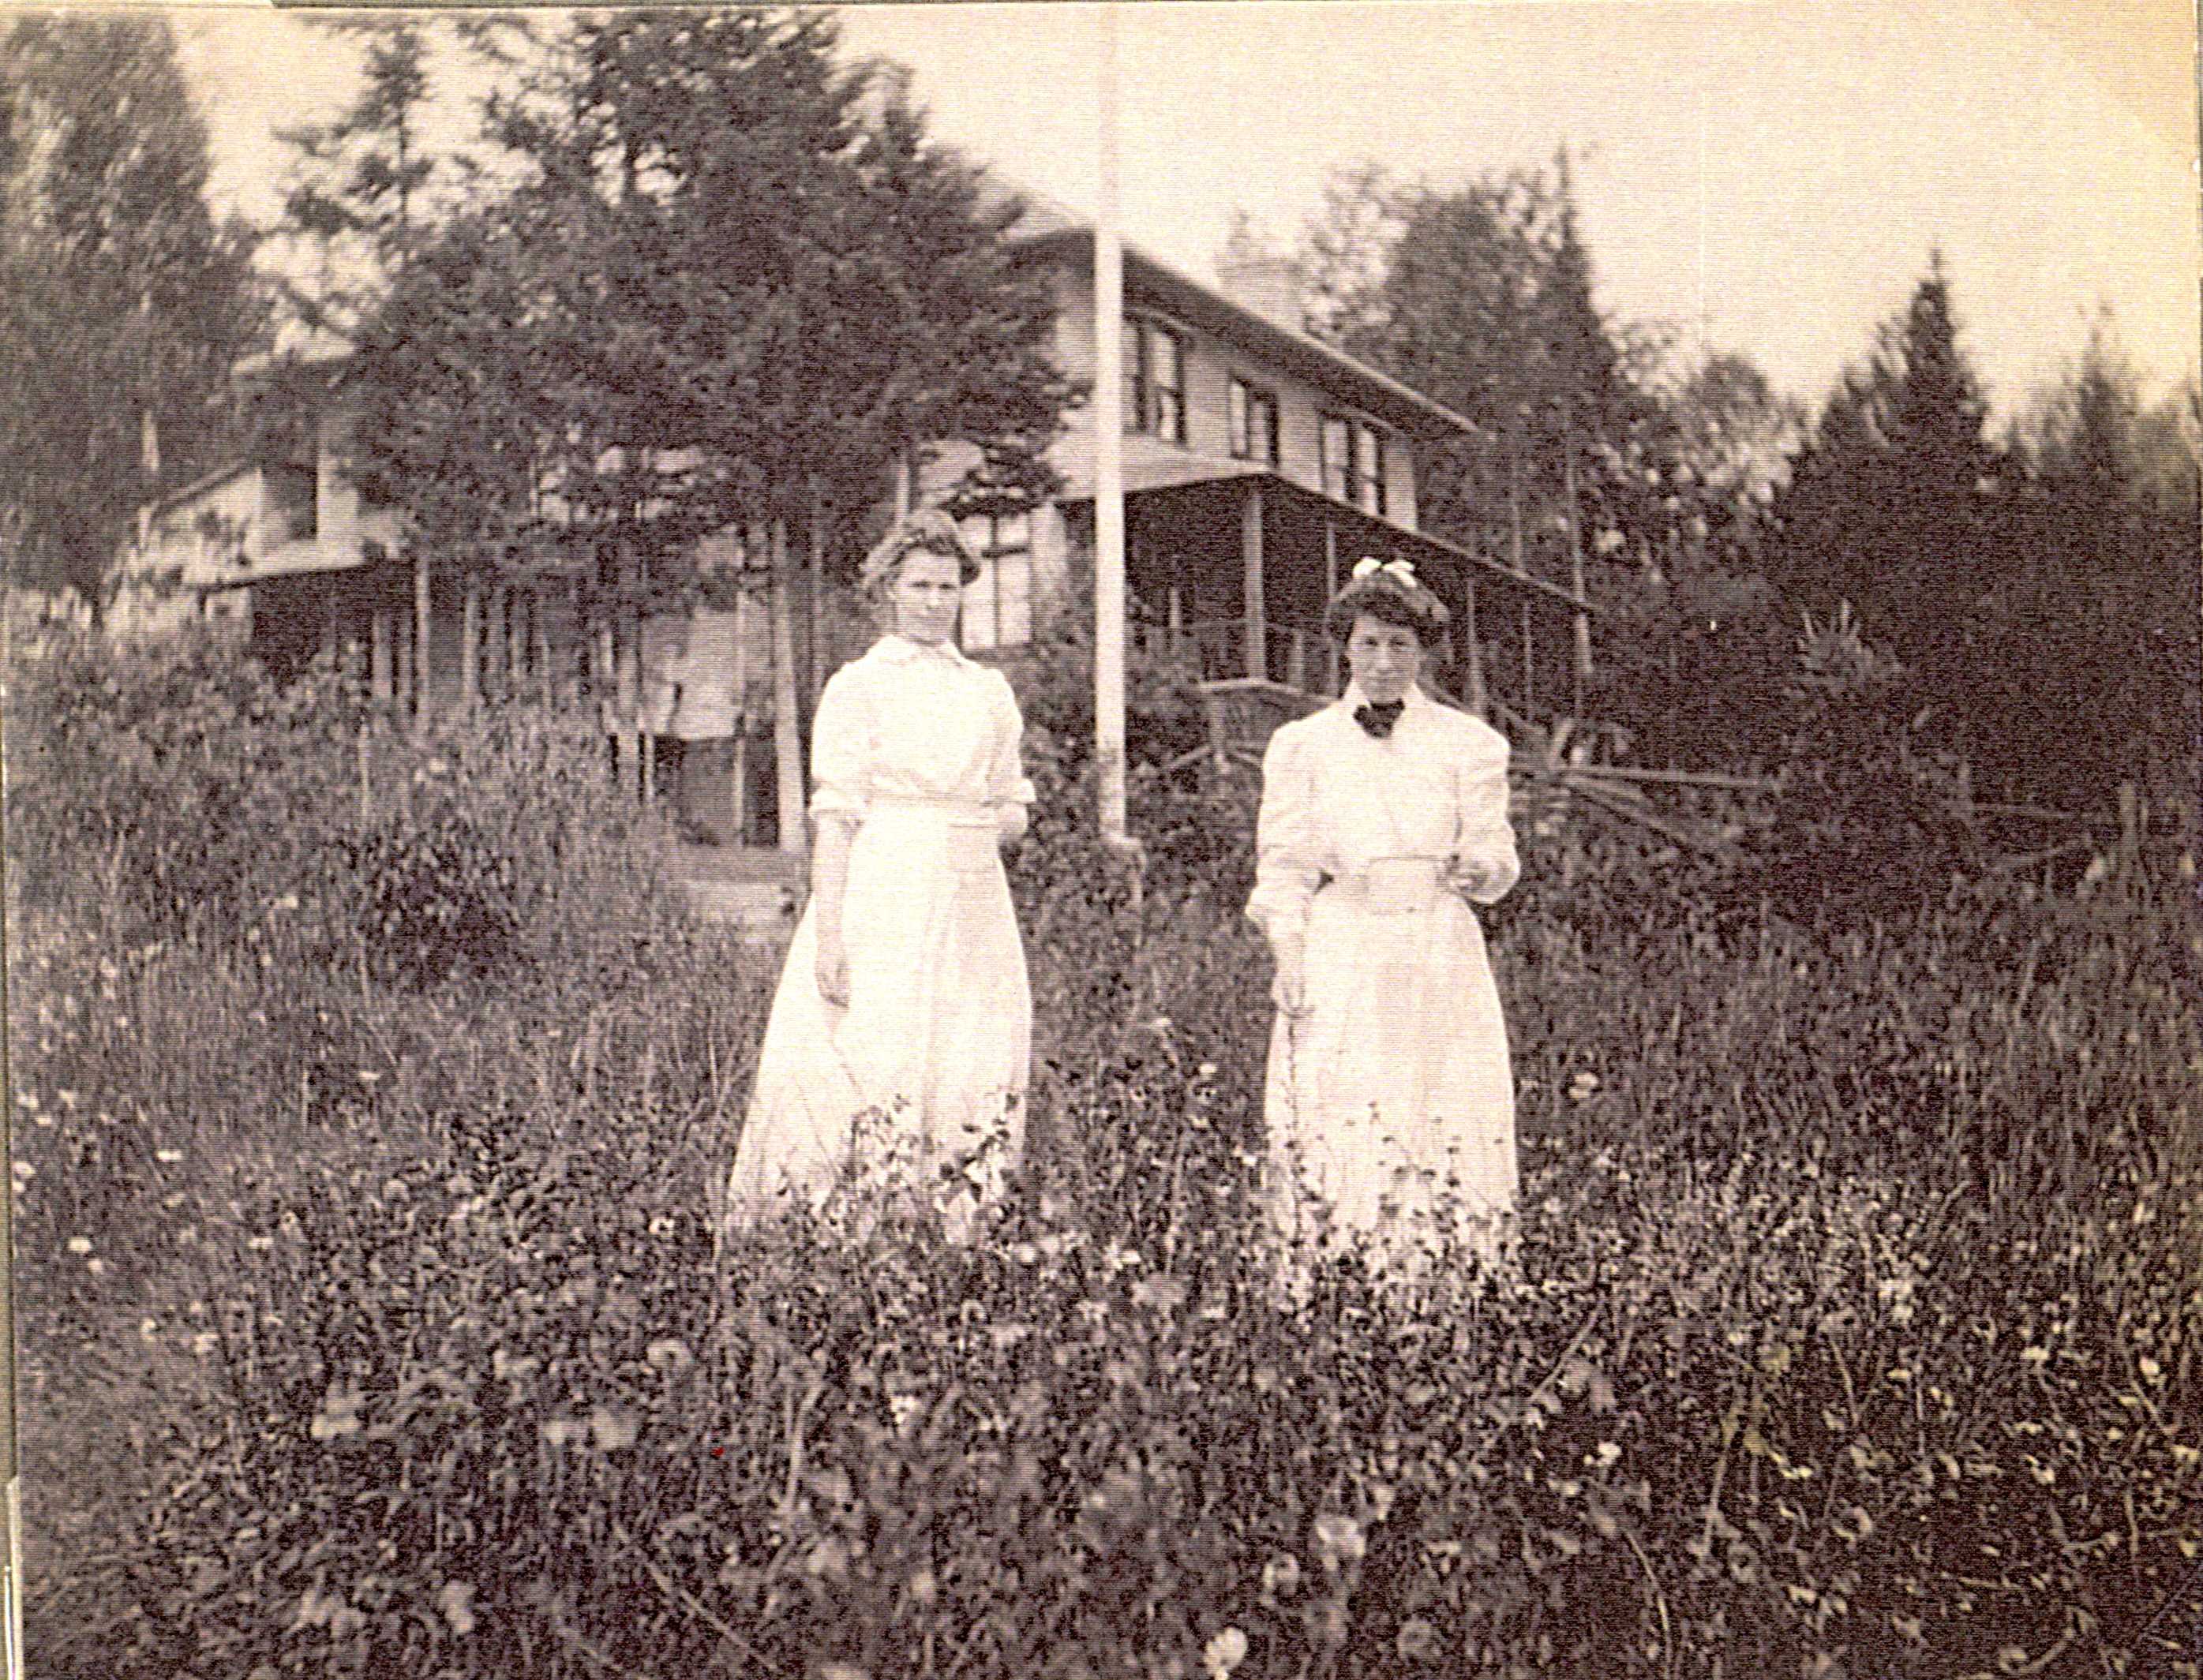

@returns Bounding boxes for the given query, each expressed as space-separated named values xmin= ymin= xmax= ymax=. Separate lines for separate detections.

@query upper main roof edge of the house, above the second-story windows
xmin=994 ymin=178 xmax=1476 ymax=436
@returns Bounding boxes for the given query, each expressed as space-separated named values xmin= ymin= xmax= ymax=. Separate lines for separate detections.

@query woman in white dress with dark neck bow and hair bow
xmin=1247 ymin=559 xmax=1520 ymax=1275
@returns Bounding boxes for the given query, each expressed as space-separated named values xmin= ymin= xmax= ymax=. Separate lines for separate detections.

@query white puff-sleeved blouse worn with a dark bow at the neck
xmin=1247 ymin=685 xmax=1523 ymax=942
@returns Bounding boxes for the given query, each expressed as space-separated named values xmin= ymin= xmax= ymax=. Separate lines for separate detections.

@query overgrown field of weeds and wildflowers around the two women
xmin=6 ymin=634 xmax=2203 ymax=1680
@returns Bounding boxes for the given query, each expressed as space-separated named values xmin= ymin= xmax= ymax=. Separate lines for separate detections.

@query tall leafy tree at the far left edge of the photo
xmin=0 ymin=13 xmax=264 ymax=619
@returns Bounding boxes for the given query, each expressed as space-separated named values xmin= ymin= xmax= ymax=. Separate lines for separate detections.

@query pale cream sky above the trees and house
xmin=174 ymin=0 xmax=2203 ymax=414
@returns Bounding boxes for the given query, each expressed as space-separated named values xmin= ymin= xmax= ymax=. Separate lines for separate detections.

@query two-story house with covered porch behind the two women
xmin=119 ymin=194 xmax=1588 ymax=844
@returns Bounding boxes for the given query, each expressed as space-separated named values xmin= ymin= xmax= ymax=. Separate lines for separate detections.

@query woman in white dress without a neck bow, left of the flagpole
xmin=727 ymin=511 xmax=1033 ymax=1235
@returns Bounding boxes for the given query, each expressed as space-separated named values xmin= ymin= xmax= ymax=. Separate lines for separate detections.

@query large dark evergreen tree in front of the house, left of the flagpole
xmin=341 ymin=9 xmax=1073 ymax=844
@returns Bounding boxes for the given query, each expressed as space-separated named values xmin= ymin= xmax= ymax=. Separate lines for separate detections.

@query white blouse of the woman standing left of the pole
xmin=811 ymin=634 xmax=1033 ymax=819
